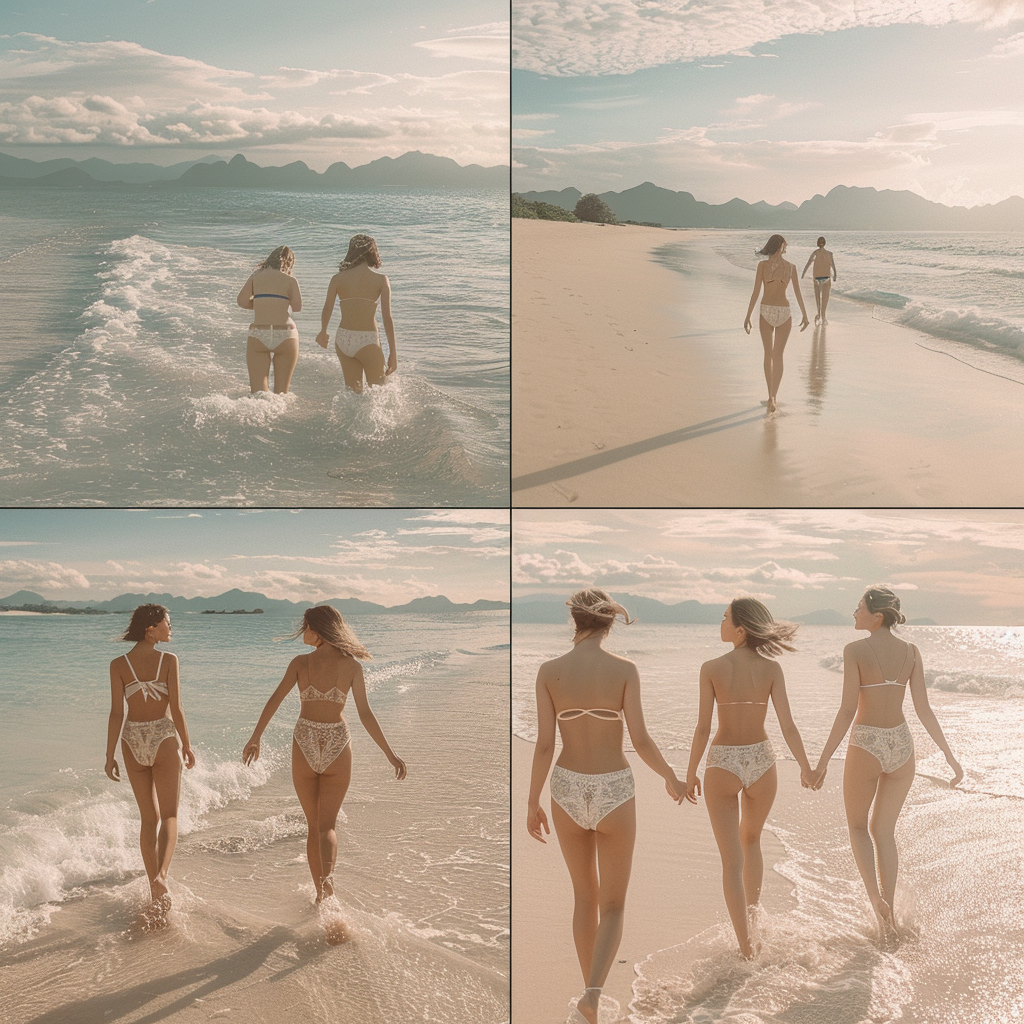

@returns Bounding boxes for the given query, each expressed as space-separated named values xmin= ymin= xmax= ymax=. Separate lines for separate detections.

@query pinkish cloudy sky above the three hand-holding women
xmin=512 ymin=509 xmax=1024 ymax=626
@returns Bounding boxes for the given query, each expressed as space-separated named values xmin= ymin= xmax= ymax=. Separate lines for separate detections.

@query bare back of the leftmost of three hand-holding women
xmin=539 ymin=645 xmax=637 ymax=774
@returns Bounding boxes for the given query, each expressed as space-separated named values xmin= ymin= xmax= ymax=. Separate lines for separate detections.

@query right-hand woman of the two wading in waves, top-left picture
xmin=316 ymin=234 xmax=398 ymax=391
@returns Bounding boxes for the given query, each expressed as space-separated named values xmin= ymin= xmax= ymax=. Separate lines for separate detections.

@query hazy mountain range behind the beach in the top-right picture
xmin=513 ymin=181 xmax=1024 ymax=231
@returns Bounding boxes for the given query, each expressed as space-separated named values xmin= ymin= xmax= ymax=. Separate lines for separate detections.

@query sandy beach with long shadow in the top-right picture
xmin=512 ymin=219 xmax=1024 ymax=507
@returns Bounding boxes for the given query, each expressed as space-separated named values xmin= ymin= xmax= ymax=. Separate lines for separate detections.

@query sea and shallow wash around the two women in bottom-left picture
xmin=0 ymin=611 xmax=509 ymax=1024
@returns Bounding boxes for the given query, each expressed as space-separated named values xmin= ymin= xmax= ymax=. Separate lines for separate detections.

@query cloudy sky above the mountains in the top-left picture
xmin=0 ymin=0 xmax=509 ymax=171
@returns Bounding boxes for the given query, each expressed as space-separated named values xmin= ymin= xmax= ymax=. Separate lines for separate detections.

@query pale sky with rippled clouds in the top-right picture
xmin=512 ymin=0 xmax=1024 ymax=206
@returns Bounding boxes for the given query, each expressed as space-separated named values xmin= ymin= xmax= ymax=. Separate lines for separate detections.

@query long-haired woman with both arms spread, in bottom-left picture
xmin=242 ymin=604 xmax=406 ymax=903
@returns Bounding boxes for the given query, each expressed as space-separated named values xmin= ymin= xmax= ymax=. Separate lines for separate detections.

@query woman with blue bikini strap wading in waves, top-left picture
xmin=238 ymin=246 xmax=302 ymax=394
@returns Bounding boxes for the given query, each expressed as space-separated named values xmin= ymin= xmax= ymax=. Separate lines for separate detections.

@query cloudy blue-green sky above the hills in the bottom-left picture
xmin=0 ymin=509 xmax=509 ymax=607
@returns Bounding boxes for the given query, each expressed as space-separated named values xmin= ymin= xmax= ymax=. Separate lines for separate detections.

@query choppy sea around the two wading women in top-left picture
xmin=0 ymin=188 xmax=510 ymax=507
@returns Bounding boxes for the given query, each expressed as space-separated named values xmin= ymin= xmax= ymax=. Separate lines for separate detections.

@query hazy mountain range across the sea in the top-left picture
xmin=0 ymin=151 xmax=510 ymax=191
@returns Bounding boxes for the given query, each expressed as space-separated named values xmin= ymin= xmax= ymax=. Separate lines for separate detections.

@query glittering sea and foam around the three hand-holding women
xmin=512 ymin=623 xmax=1024 ymax=1024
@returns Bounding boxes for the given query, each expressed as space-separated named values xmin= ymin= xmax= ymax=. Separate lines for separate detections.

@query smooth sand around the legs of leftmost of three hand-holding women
xmin=512 ymin=737 xmax=800 ymax=1024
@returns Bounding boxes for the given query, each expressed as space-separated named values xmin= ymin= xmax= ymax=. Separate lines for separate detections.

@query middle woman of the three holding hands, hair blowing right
xmin=686 ymin=597 xmax=811 ymax=959
